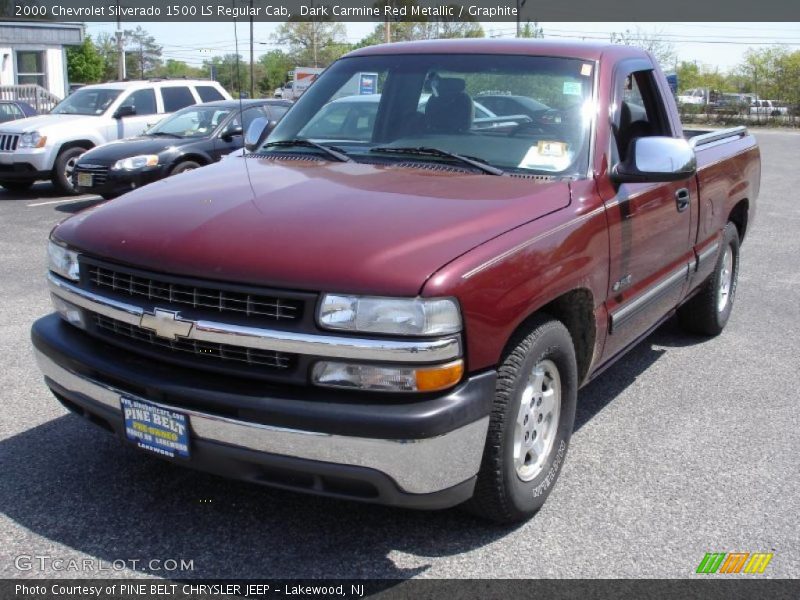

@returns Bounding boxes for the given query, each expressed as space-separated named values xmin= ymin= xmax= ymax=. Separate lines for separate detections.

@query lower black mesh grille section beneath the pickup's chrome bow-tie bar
xmin=93 ymin=314 xmax=293 ymax=369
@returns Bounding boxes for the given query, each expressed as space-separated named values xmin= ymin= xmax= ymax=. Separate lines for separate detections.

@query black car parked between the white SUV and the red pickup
xmin=74 ymin=100 xmax=291 ymax=199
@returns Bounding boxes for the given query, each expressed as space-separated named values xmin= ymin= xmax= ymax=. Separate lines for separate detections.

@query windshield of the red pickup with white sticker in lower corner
xmin=268 ymin=54 xmax=595 ymax=176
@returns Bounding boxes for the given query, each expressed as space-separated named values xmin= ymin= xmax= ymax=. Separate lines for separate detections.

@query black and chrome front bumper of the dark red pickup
xmin=32 ymin=315 xmax=495 ymax=508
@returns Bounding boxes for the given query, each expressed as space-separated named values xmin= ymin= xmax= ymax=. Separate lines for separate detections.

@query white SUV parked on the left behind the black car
xmin=0 ymin=79 xmax=231 ymax=194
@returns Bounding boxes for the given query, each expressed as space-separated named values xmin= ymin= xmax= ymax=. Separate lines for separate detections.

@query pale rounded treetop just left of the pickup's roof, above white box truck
xmin=273 ymin=20 xmax=350 ymax=67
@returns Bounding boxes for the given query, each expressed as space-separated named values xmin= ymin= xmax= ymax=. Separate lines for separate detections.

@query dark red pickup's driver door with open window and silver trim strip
xmin=604 ymin=63 xmax=698 ymax=359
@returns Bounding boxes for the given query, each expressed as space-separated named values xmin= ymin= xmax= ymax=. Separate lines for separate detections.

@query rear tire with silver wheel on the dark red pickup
xmin=678 ymin=223 xmax=739 ymax=336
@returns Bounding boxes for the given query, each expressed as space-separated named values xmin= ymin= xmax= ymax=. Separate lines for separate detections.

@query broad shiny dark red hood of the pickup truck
xmin=54 ymin=157 xmax=570 ymax=296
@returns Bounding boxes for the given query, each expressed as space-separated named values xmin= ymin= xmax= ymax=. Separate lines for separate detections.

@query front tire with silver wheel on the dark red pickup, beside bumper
xmin=464 ymin=315 xmax=578 ymax=523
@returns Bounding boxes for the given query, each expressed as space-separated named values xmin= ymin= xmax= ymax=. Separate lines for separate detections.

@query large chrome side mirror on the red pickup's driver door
xmin=611 ymin=137 xmax=697 ymax=183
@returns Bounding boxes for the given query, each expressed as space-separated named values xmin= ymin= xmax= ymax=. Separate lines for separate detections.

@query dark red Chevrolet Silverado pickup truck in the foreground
xmin=32 ymin=40 xmax=760 ymax=521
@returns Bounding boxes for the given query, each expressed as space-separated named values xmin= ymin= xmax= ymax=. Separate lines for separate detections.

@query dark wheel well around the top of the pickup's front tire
xmin=506 ymin=288 xmax=596 ymax=381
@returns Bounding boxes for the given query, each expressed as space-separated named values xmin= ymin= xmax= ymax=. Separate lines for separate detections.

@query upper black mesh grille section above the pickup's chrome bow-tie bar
xmin=87 ymin=264 xmax=302 ymax=322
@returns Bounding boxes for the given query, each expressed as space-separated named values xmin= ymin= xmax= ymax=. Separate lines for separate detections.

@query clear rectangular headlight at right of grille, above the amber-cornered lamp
xmin=318 ymin=294 xmax=461 ymax=335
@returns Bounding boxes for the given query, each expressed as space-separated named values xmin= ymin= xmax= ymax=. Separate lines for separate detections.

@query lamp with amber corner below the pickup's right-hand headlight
xmin=311 ymin=359 xmax=464 ymax=392
